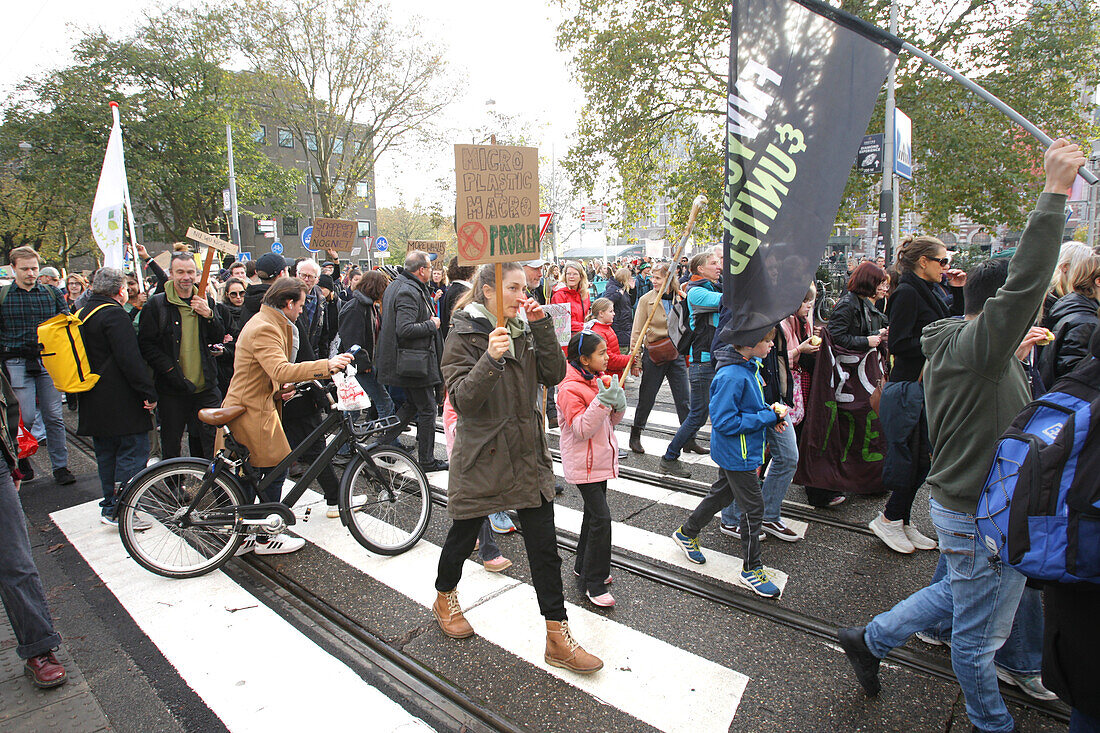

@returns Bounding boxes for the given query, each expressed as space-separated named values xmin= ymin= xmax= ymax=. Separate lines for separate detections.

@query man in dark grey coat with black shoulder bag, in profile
xmin=374 ymin=250 xmax=448 ymax=471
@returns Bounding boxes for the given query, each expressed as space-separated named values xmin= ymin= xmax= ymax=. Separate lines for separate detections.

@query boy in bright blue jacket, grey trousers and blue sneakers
xmin=672 ymin=328 xmax=787 ymax=598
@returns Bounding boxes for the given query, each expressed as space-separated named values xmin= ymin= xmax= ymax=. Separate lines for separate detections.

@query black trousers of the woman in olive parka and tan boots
xmin=436 ymin=499 xmax=567 ymax=621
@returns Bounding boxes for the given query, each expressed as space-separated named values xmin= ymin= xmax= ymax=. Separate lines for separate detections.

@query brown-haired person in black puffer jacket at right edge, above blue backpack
xmin=1040 ymin=254 xmax=1100 ymax=384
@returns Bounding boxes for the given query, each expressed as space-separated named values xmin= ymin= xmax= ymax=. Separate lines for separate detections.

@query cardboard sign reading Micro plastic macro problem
xmin=454 ymin=145 xmax=539 ymax=265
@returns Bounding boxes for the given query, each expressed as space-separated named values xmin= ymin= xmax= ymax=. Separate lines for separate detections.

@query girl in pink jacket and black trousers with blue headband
xmin=558 ymin=330 xmax=626 ymax=606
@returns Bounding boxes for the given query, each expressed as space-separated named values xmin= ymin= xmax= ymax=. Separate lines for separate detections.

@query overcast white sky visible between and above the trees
xmin=0 ymin=0 xmax=602 ymax=245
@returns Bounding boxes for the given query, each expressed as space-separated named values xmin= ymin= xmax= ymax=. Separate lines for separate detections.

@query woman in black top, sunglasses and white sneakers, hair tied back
xmin=868 ymin=236 xmax=966 ymax=555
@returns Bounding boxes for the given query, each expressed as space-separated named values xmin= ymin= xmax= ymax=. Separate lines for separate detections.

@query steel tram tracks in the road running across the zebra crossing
xmin=69 ymin=424 xmax=1069 ymax=731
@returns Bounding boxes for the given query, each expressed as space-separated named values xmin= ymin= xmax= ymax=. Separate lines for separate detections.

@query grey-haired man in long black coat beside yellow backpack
xmin=76 ymin=267 xmax=156 ymax=525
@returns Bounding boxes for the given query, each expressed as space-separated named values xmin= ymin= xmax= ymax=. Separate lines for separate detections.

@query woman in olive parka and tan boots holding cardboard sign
xmin=432 ymin=262 xmax=604 ymax=674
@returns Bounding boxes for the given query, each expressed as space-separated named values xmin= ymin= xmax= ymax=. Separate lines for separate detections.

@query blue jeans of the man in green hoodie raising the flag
xmin=864 ymin=500 xmax=1025 ymax=733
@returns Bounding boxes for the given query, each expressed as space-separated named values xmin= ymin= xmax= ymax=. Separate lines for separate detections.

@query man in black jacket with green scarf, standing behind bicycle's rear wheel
xmin=138 ymin=252 xmax=226 ymax=458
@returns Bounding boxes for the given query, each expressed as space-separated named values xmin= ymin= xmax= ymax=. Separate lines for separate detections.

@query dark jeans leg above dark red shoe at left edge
xmin=0 ymin=460 xmax=62 ymax=659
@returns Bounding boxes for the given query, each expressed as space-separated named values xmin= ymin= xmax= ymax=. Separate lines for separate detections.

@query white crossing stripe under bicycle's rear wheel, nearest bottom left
xmin=51 ymin=501 xmax=432 ymax=733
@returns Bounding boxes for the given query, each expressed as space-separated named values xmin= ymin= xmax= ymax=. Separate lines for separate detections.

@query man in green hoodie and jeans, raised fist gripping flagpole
xmin=838 ymin=139 xmax=1088 ymax=733
